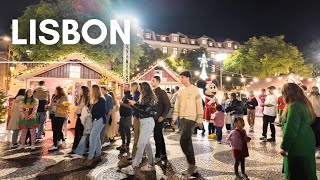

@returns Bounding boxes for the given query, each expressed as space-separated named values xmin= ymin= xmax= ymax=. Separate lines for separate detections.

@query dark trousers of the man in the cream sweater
xmin=180 ymin=119 xmax=196 ymax=165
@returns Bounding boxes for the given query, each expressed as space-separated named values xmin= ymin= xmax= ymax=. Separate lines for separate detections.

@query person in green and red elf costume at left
xmin=18 ymin=89 xmax=39 ymax=150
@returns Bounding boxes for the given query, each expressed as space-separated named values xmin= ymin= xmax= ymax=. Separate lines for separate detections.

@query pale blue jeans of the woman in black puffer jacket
xmin=132 ymin=117 xmax=155 ymax=167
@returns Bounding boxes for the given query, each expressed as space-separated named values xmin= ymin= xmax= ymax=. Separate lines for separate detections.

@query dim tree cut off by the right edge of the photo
xmin=303 ymin=41 xmax=320 ymax=76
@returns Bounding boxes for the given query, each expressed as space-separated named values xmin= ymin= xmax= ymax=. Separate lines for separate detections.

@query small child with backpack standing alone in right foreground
xmin=227 ymin=117 xmax=251 ymax=180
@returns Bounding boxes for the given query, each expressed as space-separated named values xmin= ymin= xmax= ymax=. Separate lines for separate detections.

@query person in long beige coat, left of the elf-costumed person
xmin=7 ymin=89 xmax=26 ymax=149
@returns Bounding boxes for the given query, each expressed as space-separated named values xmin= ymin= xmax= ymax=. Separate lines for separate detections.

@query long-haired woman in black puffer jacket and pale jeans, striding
xmin=121 ymin=82 xmax=157 ymax=175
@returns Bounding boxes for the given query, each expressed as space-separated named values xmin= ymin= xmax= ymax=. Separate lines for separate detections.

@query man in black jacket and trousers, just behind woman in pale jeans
xmin=151 ymin=76 xmax=171 ymax=163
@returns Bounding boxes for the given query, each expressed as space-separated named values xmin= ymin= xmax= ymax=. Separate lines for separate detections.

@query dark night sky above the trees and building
xmin=0 ymin=0 xmax=320 ymax=48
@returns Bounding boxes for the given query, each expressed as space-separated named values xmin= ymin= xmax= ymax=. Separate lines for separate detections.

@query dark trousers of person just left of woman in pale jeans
xmin=119 ymin=116 xmax=131 ymax=146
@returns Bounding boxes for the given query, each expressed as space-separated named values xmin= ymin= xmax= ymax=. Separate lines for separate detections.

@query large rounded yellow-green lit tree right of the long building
xmin=223 ymin=36 xmax=312 ymax=78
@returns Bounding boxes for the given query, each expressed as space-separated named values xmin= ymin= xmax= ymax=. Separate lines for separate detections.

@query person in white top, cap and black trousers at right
xmin=260 ymin=86 xmax=278 ymax=142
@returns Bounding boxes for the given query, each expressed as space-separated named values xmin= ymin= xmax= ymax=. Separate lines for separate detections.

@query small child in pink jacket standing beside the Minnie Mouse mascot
xmin=209 ymin=105 xmax=224 ymax=144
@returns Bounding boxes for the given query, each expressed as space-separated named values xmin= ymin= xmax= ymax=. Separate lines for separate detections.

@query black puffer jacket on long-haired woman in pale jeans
xmin=132 ymin=97 xmax=157 ymax=119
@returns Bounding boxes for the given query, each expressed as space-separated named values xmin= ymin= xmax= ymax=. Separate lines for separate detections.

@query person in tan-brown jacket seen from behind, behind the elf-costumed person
xmin=33 ymin=81 xmax=50 ymax=139
